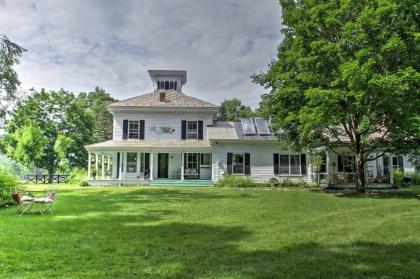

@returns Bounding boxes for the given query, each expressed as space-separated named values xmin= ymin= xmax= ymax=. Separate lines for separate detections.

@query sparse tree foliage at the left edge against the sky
xmin=0 ymin=35 xmax=26 ymax=120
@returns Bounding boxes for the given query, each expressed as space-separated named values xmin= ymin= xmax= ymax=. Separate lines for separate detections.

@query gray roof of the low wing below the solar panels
xmin=207 ymin=121 xmax=277 ymax=141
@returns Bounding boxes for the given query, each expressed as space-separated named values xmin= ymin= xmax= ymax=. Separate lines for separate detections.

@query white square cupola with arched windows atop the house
xmin=147 ymin=70 xmax=187 ymax=92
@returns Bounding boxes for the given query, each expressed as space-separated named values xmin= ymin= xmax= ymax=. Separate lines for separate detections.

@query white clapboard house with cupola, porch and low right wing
xmin=86 ymin=70 xmax=413 ymax=186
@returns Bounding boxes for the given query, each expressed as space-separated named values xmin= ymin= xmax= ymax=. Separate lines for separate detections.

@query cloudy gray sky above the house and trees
xmin=0 ymin=0 xmax=281 ymax=108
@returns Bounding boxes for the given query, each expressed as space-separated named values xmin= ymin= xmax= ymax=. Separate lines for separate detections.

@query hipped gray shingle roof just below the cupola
xmin=108 ymin=90 xmax=218 ymax=109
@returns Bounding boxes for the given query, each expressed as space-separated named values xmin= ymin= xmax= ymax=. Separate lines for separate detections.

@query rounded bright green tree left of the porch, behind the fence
xmin=5 ymin=90 xmax=94 ymax=180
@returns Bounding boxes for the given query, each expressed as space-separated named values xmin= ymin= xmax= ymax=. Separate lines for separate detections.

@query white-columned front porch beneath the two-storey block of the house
xmin=88 ymin=150 xmax=213 ymax=186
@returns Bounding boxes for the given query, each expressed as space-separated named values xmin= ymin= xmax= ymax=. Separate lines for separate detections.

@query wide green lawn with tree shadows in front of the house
xmin=0 ymin=185 xmax=420 ymax=278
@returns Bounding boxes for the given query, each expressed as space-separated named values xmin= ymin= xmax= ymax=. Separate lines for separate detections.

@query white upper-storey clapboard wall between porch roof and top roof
xmin=113 ymin=112 xmax=213 ymax=140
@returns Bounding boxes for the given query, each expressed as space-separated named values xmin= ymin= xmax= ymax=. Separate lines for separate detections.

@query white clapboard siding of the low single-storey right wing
xmin=213 ymin=142 xmax=309 ymax=182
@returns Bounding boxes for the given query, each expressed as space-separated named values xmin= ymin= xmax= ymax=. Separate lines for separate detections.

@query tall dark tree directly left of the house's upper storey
xmin=78 ymin=87 xmax=117 ymax=142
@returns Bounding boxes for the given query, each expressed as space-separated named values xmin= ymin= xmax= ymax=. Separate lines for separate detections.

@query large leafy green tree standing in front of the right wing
xmin=253 ymin=0 xmax=420 ymax=192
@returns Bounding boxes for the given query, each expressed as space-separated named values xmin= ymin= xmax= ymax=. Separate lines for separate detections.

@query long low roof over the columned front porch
xmin=85 ymin=140 xmax=211 ymax=150
